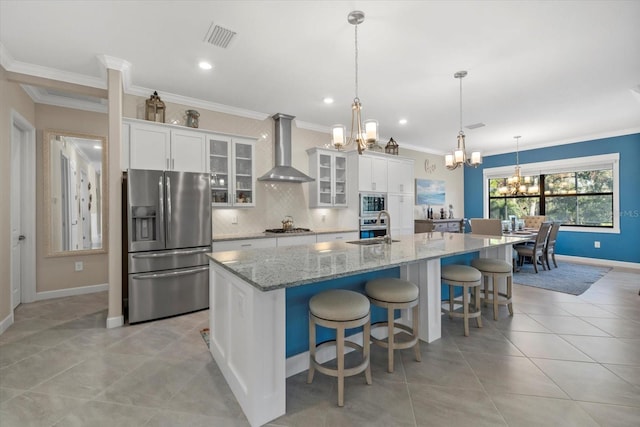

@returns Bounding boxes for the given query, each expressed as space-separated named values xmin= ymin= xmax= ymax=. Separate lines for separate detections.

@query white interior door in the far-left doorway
xmin=11 ymin=126 xmax=24 ymax=309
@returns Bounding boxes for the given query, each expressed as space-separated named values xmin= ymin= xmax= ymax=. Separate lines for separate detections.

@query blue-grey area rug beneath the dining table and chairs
xmin=513 ymin=262 xmax=611 ymax=295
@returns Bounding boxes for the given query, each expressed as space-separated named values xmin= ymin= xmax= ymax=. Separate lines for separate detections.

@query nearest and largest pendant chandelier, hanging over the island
xmin=331 ymin=10 xmax=378 ymax=154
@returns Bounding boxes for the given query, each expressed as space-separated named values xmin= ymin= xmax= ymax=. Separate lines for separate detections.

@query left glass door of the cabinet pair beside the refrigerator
xmin=209 ymin=136 xmax=231 ymax=206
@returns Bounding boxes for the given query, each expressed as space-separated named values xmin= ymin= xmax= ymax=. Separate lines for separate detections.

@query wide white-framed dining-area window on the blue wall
xmin=484 ymin=154 xmax=619 ymax=232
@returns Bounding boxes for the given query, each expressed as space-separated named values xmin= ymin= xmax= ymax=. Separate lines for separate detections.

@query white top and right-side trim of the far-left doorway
xmin=10 ymin=109 xmax=37 ymax=307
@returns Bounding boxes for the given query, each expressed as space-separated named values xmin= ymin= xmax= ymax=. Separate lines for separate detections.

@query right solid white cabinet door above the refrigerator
xmin=170 ymin=129 xmax=207 ymax=172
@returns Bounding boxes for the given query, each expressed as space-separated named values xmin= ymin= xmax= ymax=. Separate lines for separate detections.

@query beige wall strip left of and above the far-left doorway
xmin=0 ymin=67 xmax=37 ymax=322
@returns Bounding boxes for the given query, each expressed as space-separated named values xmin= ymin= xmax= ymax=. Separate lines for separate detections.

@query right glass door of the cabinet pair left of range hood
xmin=232 ymin=138 xmax=256 ymax=206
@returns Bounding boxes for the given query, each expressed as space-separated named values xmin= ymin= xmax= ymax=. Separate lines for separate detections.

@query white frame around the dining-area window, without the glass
xmin=482 ymin=153 xmax=620 ymax=234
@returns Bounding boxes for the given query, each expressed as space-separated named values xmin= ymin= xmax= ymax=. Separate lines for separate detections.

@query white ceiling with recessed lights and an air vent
xmin=0 ymin=0 xmax=640 ymax=154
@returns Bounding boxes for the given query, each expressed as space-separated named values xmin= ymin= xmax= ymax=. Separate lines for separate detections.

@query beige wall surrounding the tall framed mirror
xmin=35 ymin=104 xmax=109 ymax=292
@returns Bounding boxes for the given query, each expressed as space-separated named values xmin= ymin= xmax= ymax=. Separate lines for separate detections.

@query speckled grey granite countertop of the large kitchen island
xmin=208 ymin=231 xmax=527 ymax=291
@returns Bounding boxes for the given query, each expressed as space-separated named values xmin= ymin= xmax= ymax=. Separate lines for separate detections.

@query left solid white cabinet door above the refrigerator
xmin=129 ymin=123 xmax=171 ymax=170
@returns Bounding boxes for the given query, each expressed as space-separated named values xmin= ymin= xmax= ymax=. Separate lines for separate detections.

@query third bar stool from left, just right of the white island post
xmin=440 ymin=264 xmax=482 ymax=337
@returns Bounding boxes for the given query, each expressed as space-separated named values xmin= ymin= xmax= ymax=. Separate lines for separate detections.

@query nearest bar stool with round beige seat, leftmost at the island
xmin=307 ymin=289 xmax=371 ymax=406
